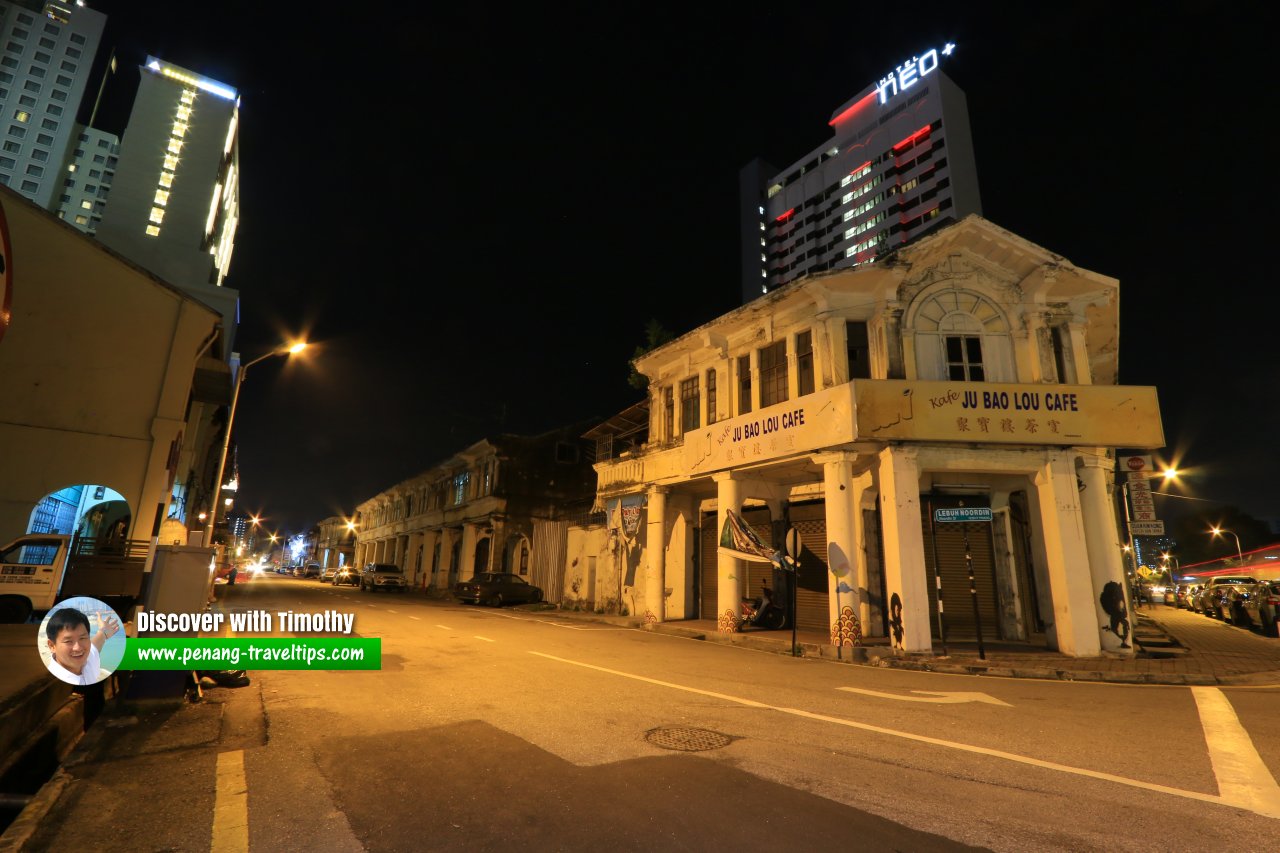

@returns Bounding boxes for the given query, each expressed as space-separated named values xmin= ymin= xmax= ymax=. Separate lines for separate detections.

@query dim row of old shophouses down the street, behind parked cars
xmin=355 ymin=424 xmax=595 ymax=601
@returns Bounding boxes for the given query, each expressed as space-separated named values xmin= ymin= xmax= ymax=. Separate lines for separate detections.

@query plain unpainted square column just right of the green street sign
xmin=1033 ymin=451 xmax=1102 ymax=657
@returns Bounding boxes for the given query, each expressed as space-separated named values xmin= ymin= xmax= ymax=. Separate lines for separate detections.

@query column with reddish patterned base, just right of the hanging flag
xmin=813 ymin=451 xmax=867 ymax=647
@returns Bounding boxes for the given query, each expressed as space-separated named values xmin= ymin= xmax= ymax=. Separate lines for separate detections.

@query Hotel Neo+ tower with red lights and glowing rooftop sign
xmin=740 ymin=45 xmax=982 ymax=304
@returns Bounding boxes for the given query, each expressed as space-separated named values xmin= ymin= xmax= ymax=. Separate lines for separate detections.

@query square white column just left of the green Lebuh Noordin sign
xmin=879 ymin=446 xmax=933 ymax=652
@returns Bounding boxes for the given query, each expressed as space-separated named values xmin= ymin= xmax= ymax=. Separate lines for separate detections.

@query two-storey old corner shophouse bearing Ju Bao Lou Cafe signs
xmin=586 ymin=215 xmax=1164 ymax=656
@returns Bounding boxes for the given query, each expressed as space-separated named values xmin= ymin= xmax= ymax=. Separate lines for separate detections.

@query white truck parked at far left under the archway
xmin=0 ymin=533 xmax=150 ymax=624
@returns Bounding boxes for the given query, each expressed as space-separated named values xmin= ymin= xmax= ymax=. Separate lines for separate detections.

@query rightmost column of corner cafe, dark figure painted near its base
xmin=1076 ymin=453 xmax=1133 ymax=654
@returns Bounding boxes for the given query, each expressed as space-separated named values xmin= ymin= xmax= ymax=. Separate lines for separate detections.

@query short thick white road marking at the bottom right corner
xmin=1192 ymin=686 xmax=1280 ymax=815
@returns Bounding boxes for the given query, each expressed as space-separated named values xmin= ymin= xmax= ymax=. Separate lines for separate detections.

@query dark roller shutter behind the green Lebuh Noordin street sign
xmin=920 ymin=496 xmax=1000 ymax=639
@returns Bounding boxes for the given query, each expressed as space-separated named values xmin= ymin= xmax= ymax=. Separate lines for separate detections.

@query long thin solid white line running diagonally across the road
xmin=529 ymin=651 xmax=1280 ymax=818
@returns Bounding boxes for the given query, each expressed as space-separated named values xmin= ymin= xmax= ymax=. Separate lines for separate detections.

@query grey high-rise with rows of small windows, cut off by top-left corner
xmin=0 ymin=0 xmax=106 ymax=206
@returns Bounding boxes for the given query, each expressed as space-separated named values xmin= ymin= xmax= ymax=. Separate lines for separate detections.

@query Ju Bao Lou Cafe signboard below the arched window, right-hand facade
xmin=852 ymin=379 xmax=1165 ymax=448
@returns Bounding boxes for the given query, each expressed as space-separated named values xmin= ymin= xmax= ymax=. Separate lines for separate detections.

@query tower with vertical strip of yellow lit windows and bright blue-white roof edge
xmin=97 ymin=56 xmax=239 ymax=290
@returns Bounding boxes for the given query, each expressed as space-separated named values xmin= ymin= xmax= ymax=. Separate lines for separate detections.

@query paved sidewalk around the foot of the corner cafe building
xmin=558 ymin=596 xmax=1280 ymax=685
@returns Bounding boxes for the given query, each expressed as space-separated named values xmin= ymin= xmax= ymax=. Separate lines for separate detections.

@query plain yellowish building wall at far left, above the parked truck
xmin=0 ymin=188 xmax=218 ymax=539
